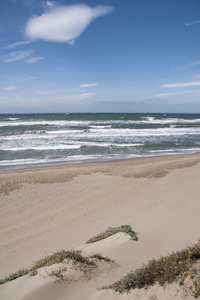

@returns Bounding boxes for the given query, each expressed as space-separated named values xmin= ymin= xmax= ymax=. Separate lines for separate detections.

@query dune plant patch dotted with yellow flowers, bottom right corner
xmin=103 ymin=241 xmax=200 ymax=298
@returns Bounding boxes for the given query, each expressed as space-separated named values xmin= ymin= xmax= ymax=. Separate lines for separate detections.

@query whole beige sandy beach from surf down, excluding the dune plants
xmin=0 ymin=154 xmax=200 ymax=300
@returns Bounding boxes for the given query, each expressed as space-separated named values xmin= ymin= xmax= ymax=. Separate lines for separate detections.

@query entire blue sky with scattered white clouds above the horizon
xmin=0 ymin=0 xmax=200 ymax=113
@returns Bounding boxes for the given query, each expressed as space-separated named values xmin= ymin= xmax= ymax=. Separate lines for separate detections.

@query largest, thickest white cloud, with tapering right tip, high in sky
xmin=25 ymin=4 xmax=113 ymax=44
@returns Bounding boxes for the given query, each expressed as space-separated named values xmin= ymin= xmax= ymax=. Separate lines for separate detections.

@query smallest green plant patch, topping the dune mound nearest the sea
xmin=86 ymin=225 xmax=138 ymax=244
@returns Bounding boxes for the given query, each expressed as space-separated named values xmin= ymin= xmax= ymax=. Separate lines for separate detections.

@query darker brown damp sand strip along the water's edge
xmin=0 ymin=153 xmax=200 ymax=195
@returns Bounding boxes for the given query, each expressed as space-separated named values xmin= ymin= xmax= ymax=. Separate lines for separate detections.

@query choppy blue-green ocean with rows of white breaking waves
xmin=0 ymin=113 xmax=200 ymax=170
